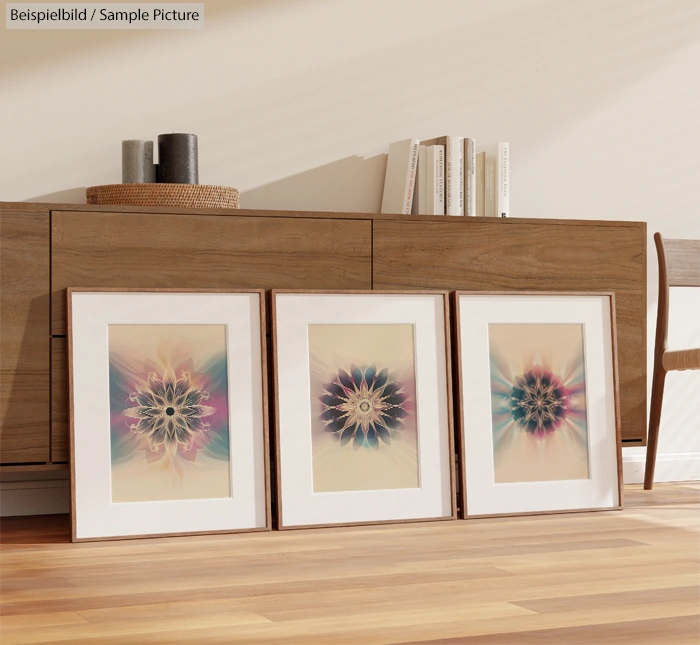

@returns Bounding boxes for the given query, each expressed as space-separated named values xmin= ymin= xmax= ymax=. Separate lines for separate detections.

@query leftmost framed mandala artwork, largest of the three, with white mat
xmin=67 ymin=289 xmax=271 ymax=541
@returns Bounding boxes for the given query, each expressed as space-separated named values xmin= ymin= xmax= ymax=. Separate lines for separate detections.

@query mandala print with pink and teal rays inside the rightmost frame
xmin=489 ymin=324 xmax=589 ymax=483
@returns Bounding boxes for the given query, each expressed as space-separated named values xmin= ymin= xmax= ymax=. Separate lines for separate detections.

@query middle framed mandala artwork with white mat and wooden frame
xmin=272 ymin=291 xmax=456 ymax=528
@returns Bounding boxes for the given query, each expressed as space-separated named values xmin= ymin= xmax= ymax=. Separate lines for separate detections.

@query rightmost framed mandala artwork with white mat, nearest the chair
xmin=454 ymin=292 xmax=622 ymax=517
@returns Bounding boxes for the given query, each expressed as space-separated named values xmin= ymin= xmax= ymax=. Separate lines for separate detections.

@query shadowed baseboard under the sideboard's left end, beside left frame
xmin=0 ymin=479 xmax=70 ymax=517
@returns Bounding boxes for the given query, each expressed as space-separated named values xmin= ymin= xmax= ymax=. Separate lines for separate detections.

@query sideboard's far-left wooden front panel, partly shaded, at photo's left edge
xmin=0 ymin=205 xmax=49 ymax=464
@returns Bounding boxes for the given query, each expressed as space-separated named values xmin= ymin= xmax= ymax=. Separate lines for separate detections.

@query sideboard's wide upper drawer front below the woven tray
xmin=51 ymin=211 xmax=372 ymax=334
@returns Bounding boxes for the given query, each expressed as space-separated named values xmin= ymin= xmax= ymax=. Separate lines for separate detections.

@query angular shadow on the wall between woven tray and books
xmin=241 ymin=154 xmax=387 ymax=213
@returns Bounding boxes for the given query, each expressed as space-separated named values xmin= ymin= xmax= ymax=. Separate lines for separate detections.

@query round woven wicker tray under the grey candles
xmin=85 ymin=184 xmax=238 ymax=208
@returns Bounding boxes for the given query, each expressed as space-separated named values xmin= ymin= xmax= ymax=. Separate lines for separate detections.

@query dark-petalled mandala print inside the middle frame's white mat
xmin=308 ymin=324 xmax=420 ymax=493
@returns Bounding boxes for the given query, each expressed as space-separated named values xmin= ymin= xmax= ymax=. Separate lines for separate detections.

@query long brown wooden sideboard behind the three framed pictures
xmin=0 ymin=202 xmax=646 ymax=472
